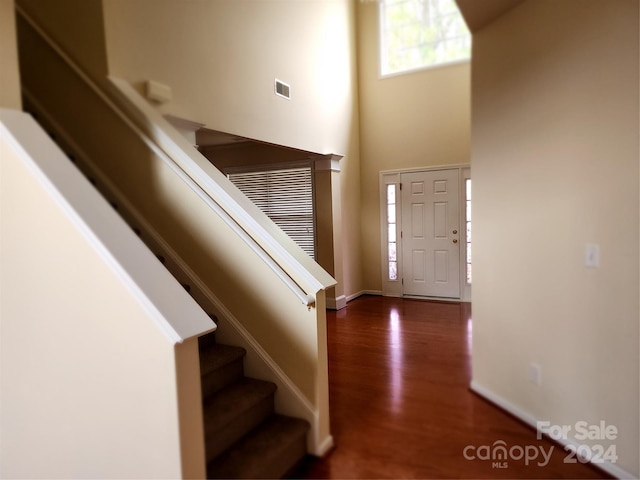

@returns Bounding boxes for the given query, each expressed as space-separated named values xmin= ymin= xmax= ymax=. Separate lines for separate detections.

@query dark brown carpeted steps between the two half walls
xmin=199 ymin=333 xmax=309 ymax=478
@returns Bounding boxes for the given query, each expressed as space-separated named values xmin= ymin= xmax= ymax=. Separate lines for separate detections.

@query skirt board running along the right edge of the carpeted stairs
xmin=23 ymin=87 xmax=334 ymax=456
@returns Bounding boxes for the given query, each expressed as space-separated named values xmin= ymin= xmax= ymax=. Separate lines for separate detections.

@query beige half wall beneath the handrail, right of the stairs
xmin=16 ymin=9 xmax=331 ymax=446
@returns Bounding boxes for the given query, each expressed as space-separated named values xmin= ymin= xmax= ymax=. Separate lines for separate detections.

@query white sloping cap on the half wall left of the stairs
xmin=0 ymin=110 xmax=216 ymax=344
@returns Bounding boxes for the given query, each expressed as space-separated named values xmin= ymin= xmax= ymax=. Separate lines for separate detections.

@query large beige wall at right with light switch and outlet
xmin=472 ymin=0 xmax=640 ymax=477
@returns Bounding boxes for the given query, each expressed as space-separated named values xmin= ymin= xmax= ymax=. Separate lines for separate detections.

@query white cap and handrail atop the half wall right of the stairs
xmin=16 ymin=5 xmax=336 ymax=307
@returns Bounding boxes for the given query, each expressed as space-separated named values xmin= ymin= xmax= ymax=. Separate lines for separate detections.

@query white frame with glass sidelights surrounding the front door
xmin=380 ymin=164 xmax=471 ymax=302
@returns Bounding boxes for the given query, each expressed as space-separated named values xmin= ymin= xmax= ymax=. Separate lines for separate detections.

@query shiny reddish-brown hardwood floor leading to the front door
xmin=293 ymin=296 xmax=606 ymax=479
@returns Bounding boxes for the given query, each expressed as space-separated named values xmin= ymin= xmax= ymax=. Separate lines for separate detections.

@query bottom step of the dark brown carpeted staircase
xmin=207 ymin=415 xmax=309 ymax=478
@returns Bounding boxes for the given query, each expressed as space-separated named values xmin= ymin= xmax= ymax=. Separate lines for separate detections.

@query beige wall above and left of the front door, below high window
xmin=357 ymin=1 xmax=470 ymax=291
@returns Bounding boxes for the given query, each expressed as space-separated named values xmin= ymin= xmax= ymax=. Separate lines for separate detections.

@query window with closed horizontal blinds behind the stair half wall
xmin=227 ymin=167 xmax=315 ymax=258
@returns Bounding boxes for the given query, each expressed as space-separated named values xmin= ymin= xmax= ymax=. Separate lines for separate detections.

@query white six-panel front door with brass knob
xmin=400 ymin=169 xmax=462 ymax=298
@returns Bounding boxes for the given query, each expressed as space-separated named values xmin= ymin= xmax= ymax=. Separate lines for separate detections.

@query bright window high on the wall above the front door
xmin=380 ymin=0 xmax=471 ymax=76
